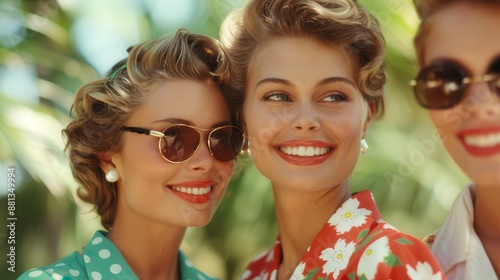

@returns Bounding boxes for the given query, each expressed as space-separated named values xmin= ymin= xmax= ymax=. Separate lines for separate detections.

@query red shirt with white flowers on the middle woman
xmin=242 ymin=190 xmax=446 ymax=280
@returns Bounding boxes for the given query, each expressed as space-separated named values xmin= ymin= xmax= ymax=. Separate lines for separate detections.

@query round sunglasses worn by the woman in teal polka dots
xmin=120 ymin=124 xmax=244 ymax=163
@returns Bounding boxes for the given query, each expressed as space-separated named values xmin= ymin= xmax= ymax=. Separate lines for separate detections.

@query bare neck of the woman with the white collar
xmin=474 ymin=186 xmax=500 ymax=277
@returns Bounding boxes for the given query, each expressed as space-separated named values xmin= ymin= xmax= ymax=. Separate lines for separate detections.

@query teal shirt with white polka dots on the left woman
xmin=18 ymin=231 xmax=215 ymax=280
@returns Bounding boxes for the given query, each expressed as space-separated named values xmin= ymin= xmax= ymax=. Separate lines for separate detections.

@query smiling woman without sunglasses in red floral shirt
xmin=221 ymin=0 xmax=443 ymax=280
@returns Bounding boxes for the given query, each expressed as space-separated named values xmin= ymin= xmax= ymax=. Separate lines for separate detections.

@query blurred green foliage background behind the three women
xmin=0 ymin=0 xmax=467 ymax=279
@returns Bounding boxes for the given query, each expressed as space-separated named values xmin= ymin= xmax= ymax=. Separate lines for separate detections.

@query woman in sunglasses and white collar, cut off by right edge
xmin=412 ymin=0 xmax=500 ymax=279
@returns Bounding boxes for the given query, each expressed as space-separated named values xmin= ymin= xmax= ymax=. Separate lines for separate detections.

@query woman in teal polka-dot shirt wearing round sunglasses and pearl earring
xmin=21 ymin=27 xmax=243 ymax=279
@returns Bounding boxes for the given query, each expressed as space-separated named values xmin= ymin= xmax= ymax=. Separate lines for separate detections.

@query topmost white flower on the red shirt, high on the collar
xmin=328 ymin=198 xmax=372 ymax=234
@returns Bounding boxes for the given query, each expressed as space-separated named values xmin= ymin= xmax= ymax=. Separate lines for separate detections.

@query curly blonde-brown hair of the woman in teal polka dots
xmin=63 ymin=29 xmax=229 ymax=230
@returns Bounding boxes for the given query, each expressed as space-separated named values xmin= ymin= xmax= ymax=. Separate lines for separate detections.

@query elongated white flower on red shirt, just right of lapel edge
xmin=357 ymin=236 xmax=390 ymax=280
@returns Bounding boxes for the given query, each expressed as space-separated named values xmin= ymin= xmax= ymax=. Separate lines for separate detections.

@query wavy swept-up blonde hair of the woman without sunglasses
xmin=220 ymin=0 xmax=386 ymax=117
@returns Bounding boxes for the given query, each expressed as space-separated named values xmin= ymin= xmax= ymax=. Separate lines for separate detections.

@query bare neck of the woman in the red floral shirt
xmin=273 ymin=183 xmax=351 ymax=279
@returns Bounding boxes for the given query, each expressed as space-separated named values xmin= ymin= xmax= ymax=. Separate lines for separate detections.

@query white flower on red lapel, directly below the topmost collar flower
xmin=320 ymin=238 xmax=356 ymax=278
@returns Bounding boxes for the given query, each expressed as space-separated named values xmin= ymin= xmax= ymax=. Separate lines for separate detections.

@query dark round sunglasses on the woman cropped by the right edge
xmin=410 ymin=56 xmax=500 ymax=109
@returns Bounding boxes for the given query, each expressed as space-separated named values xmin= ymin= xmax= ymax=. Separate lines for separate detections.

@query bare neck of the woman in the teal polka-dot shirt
xmin=108 ymin=217 xmax=186 ymax=279
